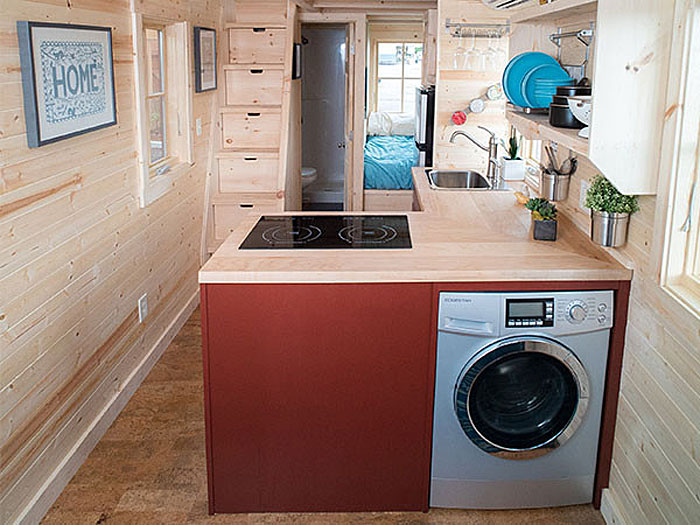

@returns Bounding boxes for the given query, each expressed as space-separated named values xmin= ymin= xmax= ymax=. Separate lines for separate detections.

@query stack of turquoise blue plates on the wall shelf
xmin=503 ymin=51 xmax=574 ymax=108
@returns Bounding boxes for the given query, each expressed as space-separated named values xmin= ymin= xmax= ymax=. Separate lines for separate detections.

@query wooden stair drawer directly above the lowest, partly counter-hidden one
xmin=219 ymin=153 xmax=279 ymax=193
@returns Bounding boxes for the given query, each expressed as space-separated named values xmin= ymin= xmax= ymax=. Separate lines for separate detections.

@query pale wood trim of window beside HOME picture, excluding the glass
xmin=132 ymin=13 xmax=194 ymax=208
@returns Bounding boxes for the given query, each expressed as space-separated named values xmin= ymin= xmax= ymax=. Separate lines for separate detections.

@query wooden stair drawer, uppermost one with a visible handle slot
xmin=229 ymin=27 xmax=286 ymax=64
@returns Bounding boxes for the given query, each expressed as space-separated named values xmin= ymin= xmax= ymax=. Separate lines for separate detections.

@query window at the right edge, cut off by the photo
xmin=661 ymin=3 xmax=700 ymax=316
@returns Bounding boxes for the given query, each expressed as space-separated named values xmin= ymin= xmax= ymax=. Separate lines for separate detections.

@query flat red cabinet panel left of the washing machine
xmin=202 ymin=283 xmax=435 ymax=512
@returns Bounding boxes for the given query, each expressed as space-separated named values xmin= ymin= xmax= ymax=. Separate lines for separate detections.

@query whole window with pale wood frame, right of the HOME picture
xmin=133 ymin=13 xmax=194 ymax=207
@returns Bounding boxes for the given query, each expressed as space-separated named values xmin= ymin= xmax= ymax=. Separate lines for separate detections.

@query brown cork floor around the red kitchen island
xmin=42 ymin=310 xmax=604 ymax=525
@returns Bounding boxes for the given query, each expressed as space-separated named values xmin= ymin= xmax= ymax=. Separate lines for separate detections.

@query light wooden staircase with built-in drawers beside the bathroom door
xmin=207 ymin=0 xmax=294 ymax=253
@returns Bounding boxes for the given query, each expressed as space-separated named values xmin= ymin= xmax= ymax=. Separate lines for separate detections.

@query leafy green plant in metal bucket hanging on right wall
xmin=585 ymin=175 xmax=639 ymax=248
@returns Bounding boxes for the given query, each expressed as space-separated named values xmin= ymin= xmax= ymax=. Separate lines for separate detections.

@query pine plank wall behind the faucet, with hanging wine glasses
xmin=433 ymin=0 xmax=509 ymax=173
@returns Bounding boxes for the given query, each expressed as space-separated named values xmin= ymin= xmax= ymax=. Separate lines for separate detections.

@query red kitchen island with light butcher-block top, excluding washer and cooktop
xmin=200 ymin=169 xmax=631 ymax=512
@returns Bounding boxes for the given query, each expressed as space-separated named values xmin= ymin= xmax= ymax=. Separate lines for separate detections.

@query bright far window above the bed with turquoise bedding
xmin=375 ymin=42 xmax=423 ymax=113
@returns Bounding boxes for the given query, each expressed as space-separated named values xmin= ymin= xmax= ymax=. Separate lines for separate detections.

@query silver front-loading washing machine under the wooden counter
xmin=430 ymin=291 xmax=613 ymax=509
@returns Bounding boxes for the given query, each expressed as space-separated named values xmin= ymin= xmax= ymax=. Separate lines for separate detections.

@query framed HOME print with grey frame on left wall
xmin=17 ymin=21 xmax=117 ymax=148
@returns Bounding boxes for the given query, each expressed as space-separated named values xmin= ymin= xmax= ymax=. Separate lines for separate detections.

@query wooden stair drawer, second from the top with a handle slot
xmin=225 ymin=66 xmax=284 ymax=106
